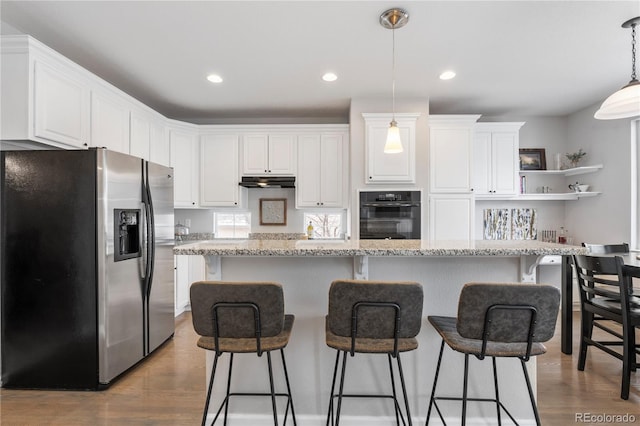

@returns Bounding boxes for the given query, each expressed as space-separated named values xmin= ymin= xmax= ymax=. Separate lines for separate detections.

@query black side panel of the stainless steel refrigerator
xmin=0 ymin=151 xmax=98 ymax=389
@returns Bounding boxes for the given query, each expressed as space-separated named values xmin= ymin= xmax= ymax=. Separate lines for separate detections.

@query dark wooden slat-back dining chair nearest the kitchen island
xmin=574 ymin=255 xmax=640 ymax=399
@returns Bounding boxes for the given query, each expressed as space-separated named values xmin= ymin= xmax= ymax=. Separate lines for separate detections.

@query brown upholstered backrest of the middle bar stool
xmin=328 ymin=280 xmax=423 ymax=339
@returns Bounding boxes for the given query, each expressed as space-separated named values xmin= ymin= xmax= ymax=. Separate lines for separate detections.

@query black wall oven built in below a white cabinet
xmin=360 ymin=191 xmax=420 ymax=240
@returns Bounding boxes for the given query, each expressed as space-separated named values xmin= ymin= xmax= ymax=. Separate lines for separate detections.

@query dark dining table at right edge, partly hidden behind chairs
xmin=560 ymin=252 xmax=640 ymax=355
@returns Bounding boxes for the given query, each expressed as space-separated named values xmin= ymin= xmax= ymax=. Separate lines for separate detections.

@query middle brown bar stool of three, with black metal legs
xmin=325 ymin=280 xmax=423 ymax=426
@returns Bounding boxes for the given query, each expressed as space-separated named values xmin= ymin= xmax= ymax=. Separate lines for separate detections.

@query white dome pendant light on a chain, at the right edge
xmin=594 ymin=16 xmax=640 ymax=120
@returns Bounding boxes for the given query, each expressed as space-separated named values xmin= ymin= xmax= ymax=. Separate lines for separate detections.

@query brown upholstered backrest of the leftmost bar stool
xmin=191 ymin=281 xmax=284 ymax=338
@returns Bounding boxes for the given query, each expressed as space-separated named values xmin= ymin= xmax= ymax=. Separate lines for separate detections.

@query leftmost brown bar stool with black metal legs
xmin=190 ymin=281 xmax=297 ymax=426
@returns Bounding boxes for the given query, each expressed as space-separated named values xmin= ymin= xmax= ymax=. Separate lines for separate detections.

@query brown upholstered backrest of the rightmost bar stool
xmin=457 ymin=283 xmax=560 ymax=343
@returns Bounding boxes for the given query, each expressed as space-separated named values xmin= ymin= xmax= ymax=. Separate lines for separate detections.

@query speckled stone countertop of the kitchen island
xmin=173 ymin=240 xmax=588 ymax=256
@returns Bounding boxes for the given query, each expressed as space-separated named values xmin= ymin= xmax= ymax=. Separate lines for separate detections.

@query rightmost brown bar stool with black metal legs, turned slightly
xmin=426 ymin=283 xmax=560 ymax=426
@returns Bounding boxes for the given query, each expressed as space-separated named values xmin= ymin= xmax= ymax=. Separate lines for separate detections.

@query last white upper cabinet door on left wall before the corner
xmin=169 ymin=129 xmax=200 ymax=208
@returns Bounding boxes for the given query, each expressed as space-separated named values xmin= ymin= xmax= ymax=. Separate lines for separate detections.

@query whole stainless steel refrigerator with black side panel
xmin=0 ymin=148 xmax=174 ymax=389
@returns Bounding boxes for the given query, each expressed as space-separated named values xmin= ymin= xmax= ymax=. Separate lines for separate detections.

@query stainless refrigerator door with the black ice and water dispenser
xmin=97 ymin=149 xmax=144 ymax=384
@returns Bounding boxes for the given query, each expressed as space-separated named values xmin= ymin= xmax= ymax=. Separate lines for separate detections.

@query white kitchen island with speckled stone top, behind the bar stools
xmin=174 ymin=240 xmax=586 ymax=425
